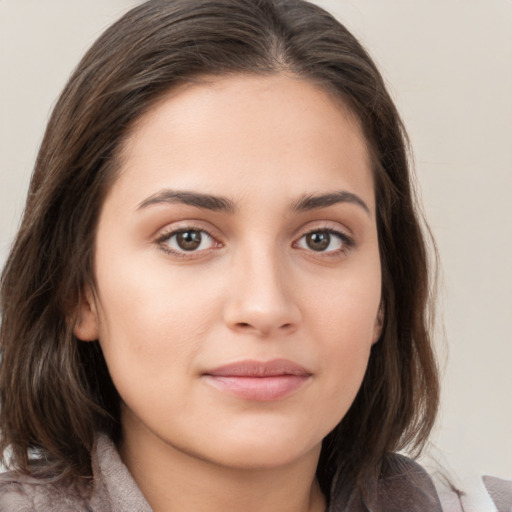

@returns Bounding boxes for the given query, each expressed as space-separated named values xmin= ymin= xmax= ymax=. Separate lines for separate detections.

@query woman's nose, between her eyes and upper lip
xmin=224 ymin=247 xmax=301 ymax=337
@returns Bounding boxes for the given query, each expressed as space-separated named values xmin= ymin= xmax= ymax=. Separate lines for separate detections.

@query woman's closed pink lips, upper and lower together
xmin=203 ymin=359 xmax=311 ymax=402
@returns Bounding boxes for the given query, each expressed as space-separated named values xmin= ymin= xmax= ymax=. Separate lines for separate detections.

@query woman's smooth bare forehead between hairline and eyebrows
xmin=110 ymin=74 xmax=373 ymax=212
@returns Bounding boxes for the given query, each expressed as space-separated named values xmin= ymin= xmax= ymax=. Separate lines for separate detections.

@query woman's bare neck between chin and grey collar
xmin=120 ymin=420 xmax=325 ymax=512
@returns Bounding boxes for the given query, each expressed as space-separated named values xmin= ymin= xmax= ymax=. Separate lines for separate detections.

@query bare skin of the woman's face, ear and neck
xmin=75 ymin=74 xmax=381 ymax=512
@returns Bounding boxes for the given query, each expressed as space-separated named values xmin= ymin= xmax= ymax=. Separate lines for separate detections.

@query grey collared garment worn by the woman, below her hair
xmin=0 ymin=436 xmax=441 ymax=512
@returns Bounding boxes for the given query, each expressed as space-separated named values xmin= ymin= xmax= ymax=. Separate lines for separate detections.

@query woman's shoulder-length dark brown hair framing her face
xmin=0 ymin=0 xmax=439 ymax=504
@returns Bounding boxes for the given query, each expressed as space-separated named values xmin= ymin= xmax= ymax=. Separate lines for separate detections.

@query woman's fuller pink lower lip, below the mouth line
xmin=205 ymin=375 xmax=309 ymax=402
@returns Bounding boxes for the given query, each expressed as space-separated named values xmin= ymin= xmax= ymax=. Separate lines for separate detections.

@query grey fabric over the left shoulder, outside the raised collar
xmin=0 ymin=471 xmax=88 ymax=512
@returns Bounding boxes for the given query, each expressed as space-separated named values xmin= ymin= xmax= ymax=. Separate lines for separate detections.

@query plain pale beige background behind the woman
xmin=0 ymin=0 xmax=512 ymax=504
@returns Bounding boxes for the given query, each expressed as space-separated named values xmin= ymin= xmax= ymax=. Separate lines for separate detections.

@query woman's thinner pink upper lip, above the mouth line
xmin=205 ymin=359 xmax=311 ymax=377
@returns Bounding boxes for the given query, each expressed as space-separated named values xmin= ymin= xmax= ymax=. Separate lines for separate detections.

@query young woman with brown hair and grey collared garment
xmin=0 ymin=0 xmax=439 ymax=511
